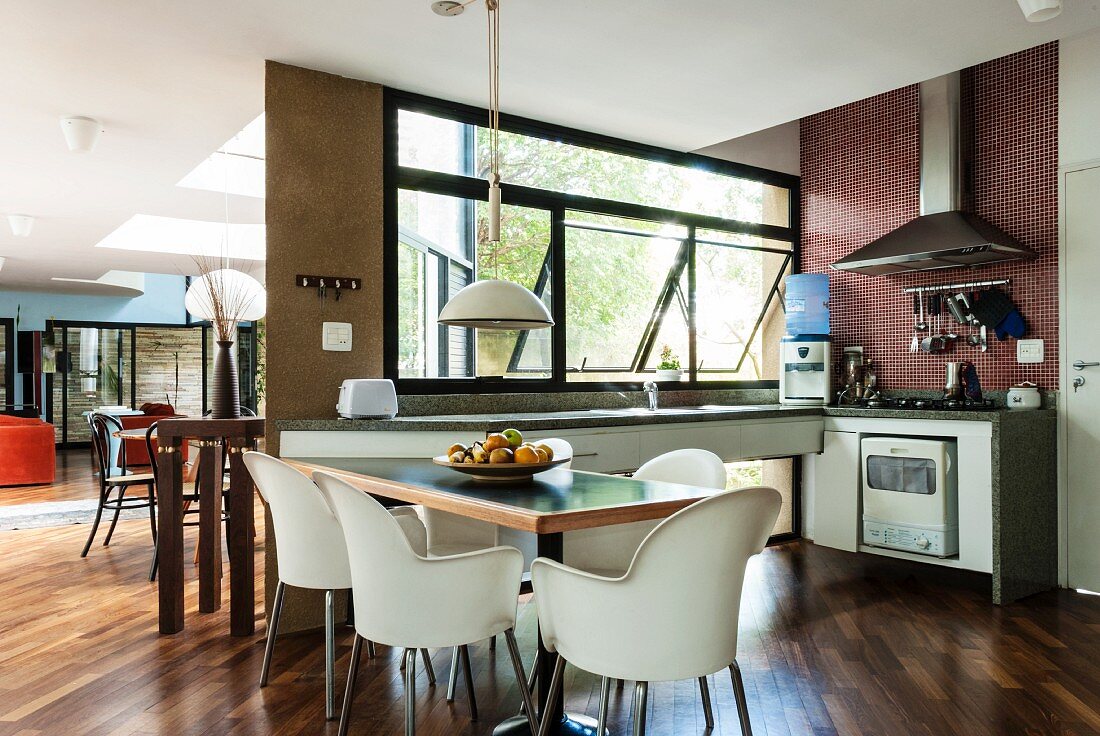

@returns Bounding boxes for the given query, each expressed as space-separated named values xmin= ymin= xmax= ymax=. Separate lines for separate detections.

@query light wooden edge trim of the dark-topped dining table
xmin=283 ymin=458 xmax=717 ymax=535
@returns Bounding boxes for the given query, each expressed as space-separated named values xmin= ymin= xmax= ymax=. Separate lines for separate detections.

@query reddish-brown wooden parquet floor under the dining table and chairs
xmin=0 ymin=508 xmax=1100 ymax=736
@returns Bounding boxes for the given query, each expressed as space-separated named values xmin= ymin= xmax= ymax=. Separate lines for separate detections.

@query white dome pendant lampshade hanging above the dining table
xmin=439 ymin=278 xmax=553 ymax=330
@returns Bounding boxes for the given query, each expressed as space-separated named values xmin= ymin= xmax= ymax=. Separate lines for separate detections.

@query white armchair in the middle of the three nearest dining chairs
xmin=314 ymin=471 xmax=536 ymax=736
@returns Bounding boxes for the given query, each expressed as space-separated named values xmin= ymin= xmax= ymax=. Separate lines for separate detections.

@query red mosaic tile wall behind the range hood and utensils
xmin=801 ymin=43 xmax=1058 ymax=389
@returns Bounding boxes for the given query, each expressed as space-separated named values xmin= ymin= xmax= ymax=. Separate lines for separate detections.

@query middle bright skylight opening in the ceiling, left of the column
xmin=96 ymin=215 xmax=267 ymax=261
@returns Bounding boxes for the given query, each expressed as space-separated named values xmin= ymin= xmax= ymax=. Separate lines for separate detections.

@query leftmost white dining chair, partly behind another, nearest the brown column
xmin=244 ymin=452 xmax=435 ymax=721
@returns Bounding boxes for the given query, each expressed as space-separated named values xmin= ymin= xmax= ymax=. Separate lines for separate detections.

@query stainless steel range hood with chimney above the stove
xmin=833 ymin=72 xmax=1038 ymax=276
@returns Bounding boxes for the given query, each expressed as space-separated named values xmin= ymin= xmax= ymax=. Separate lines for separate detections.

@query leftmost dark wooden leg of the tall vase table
xmin=155 ymin=437 xmax=184 ymax=634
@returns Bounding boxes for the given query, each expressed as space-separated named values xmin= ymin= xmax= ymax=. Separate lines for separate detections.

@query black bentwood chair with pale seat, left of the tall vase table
xmin=80 ymin=413 xmax=156 ymax=557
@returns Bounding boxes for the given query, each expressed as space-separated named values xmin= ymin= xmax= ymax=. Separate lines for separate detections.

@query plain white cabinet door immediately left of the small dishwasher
xmin=812 ymin=431 xmax=859 ymax=552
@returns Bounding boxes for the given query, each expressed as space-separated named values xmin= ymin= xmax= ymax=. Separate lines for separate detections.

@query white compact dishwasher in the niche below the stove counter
xmin=860 ymin=436 xmax=959 ymax=558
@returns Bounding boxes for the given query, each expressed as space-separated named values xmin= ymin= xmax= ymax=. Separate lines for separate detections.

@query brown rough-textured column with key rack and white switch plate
xmin=264 ymin=62 xmax=383 ymax=630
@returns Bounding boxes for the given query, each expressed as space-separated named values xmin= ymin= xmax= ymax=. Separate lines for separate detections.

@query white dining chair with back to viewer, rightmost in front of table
xmin=531 ymin=487 xmax=782 ymax=736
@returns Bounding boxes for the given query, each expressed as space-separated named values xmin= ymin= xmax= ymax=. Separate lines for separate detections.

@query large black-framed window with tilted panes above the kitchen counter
xmin=384 ymin=89 xmax=799 ymax=393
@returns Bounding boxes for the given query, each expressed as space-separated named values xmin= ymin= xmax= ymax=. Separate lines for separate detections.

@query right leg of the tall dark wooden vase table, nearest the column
xmin=229 ymin=438 xmax=256 ymax=636
